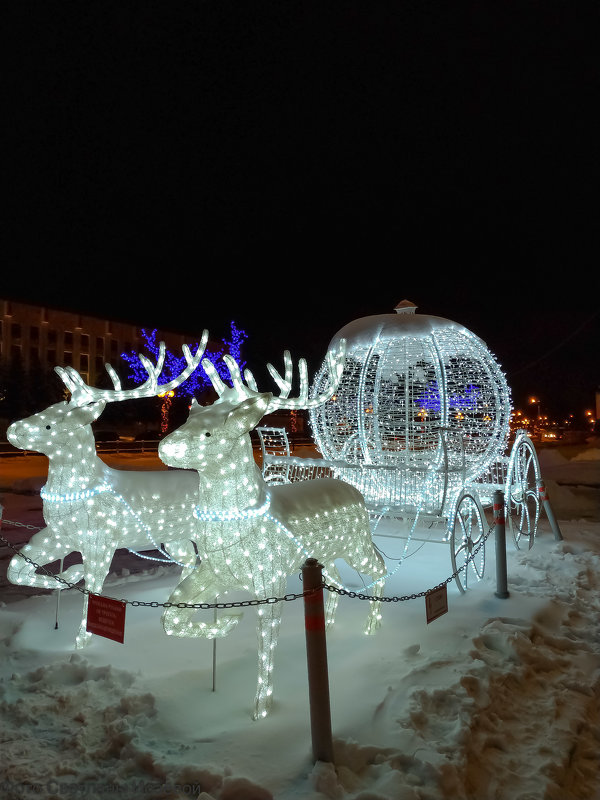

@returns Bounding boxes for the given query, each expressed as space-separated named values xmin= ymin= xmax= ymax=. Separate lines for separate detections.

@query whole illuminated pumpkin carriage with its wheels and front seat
xmin=259 ymin=301 xmax=541 ymax=590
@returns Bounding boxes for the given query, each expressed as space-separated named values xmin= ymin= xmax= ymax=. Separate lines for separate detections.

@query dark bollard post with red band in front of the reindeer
xmin=302 ymin=558 xmax=333 ymax=763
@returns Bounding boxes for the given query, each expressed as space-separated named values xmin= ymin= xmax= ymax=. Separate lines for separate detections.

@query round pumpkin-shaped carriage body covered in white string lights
xmin=311 ymin=303 xmax=510 ymax=515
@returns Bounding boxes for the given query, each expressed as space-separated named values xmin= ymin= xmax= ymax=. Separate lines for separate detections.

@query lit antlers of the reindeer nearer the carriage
xmin=202 ymin=339 xmax=346 ymax=414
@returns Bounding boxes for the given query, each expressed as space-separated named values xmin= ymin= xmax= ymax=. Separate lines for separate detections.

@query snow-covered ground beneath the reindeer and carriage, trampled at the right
xmin=0 ymin=442 xmax=600 ymax=800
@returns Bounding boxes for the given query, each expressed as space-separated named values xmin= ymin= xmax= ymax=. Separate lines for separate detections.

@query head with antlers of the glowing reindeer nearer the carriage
xmin=158 ymin=341 xmax=345 ymax=472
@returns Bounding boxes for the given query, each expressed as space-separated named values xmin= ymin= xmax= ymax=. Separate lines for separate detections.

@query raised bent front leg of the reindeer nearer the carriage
xmin=161 ymin=565 xmax=243 ymax=639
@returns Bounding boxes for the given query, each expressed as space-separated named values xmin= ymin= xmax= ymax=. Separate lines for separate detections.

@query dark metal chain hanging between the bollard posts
xmin=0 ymin=520 xmax=494 ymax=610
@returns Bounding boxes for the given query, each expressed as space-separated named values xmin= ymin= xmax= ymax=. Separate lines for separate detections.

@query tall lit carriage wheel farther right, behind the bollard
xmin=504 ymin=435 xmax=541 ymax=548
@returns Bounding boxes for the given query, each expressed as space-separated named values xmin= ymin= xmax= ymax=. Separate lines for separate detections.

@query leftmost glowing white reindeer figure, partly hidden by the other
xmin=7 ymin=331 xmax=208 ymax=648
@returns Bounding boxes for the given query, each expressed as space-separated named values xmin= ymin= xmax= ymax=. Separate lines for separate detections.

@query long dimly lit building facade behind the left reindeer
xmin=0 ymin=298 xmax=211 ymax=386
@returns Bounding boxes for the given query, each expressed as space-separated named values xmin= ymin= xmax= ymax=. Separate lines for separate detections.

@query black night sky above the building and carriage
xmin=0 ymin=0 xmax=600 ymax=414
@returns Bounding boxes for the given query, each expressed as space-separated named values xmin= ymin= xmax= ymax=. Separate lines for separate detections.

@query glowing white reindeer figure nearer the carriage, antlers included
xmin=159 ymin=346 xmax=385 ymax=719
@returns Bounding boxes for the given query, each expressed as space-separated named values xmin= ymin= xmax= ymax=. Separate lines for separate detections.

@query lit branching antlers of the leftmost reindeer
xmin=54 ymin=330 xmax=208 ymax=406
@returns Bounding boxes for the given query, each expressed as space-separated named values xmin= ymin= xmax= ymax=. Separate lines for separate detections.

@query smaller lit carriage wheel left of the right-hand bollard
xmin=450 ymin=492 xmax=485 ymax=592
